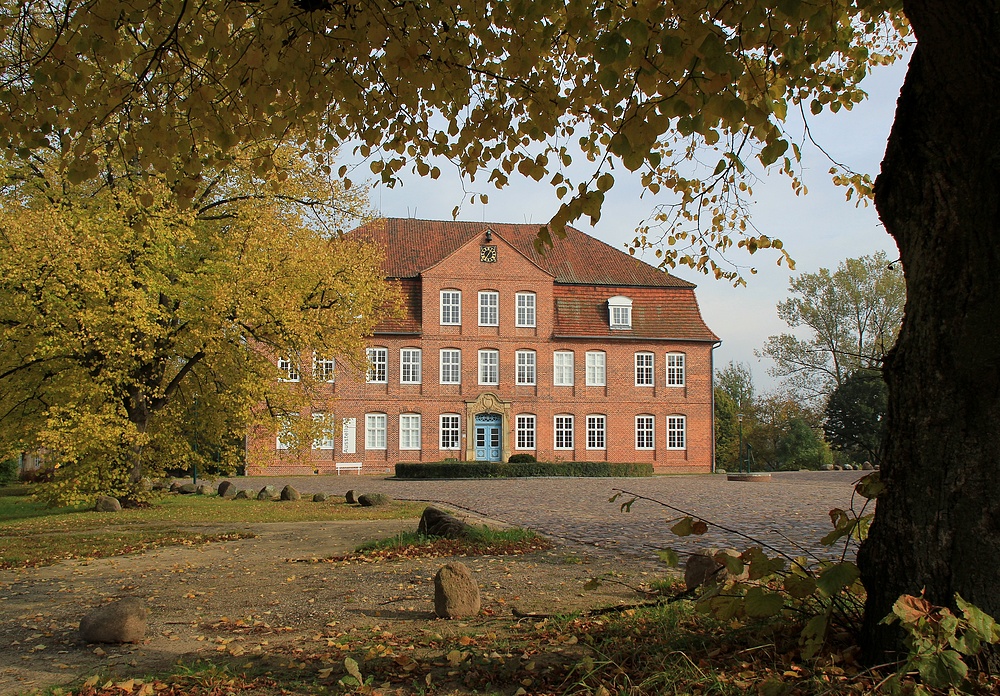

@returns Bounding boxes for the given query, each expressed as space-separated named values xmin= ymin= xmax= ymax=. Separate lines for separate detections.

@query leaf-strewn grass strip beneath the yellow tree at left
xmin=0 ymin=495 xmax=424 ymax=568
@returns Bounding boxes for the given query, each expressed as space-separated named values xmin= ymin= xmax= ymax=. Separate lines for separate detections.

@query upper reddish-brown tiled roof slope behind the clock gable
xmin=348 ymin=218 xmax=695 ymax=288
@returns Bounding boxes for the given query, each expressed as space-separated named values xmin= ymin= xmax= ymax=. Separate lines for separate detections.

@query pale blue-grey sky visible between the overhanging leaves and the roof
xmin=371 ymin=62 xmax=905 ymax=392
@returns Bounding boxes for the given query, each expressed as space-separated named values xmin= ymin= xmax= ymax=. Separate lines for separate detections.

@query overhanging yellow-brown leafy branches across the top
xmin=0 ymin=0 xmax=908 ymax=278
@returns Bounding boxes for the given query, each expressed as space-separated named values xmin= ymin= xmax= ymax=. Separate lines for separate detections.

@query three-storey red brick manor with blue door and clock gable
xmin=249 ymin=219 xmax=719 ymax=474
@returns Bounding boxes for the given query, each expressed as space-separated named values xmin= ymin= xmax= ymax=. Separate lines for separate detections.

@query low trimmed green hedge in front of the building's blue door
xmin=396 ymin=462 xmax=653 ymax=479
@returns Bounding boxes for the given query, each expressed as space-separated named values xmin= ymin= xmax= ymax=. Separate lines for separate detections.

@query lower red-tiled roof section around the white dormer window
xmin=554 ymin=285 xmax=719 ymax=341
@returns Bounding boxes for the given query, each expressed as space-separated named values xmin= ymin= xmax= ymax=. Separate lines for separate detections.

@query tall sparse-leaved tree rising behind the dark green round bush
xmin=762 ymin=251 xmax=906 ymax=400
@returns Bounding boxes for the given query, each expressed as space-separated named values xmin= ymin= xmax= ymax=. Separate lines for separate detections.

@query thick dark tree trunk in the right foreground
xmin=859 ymin=0 xmax=1000 ymax=666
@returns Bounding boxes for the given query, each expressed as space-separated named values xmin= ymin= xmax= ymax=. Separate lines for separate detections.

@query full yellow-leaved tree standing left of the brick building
xmin=0 ymin=150 xmax=389 ymax=503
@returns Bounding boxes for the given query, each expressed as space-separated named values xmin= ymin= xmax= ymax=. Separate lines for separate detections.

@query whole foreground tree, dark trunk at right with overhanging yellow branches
xmin=0 ymin=0 xmax=1000 ymax=658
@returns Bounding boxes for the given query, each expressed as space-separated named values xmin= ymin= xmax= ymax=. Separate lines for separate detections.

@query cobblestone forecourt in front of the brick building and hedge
xmin=225 ymin=471 xmax=865 ymax=557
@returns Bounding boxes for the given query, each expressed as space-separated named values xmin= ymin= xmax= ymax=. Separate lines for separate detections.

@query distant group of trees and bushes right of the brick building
xmin=715 ymin=252 xmax=906 ymax=470
